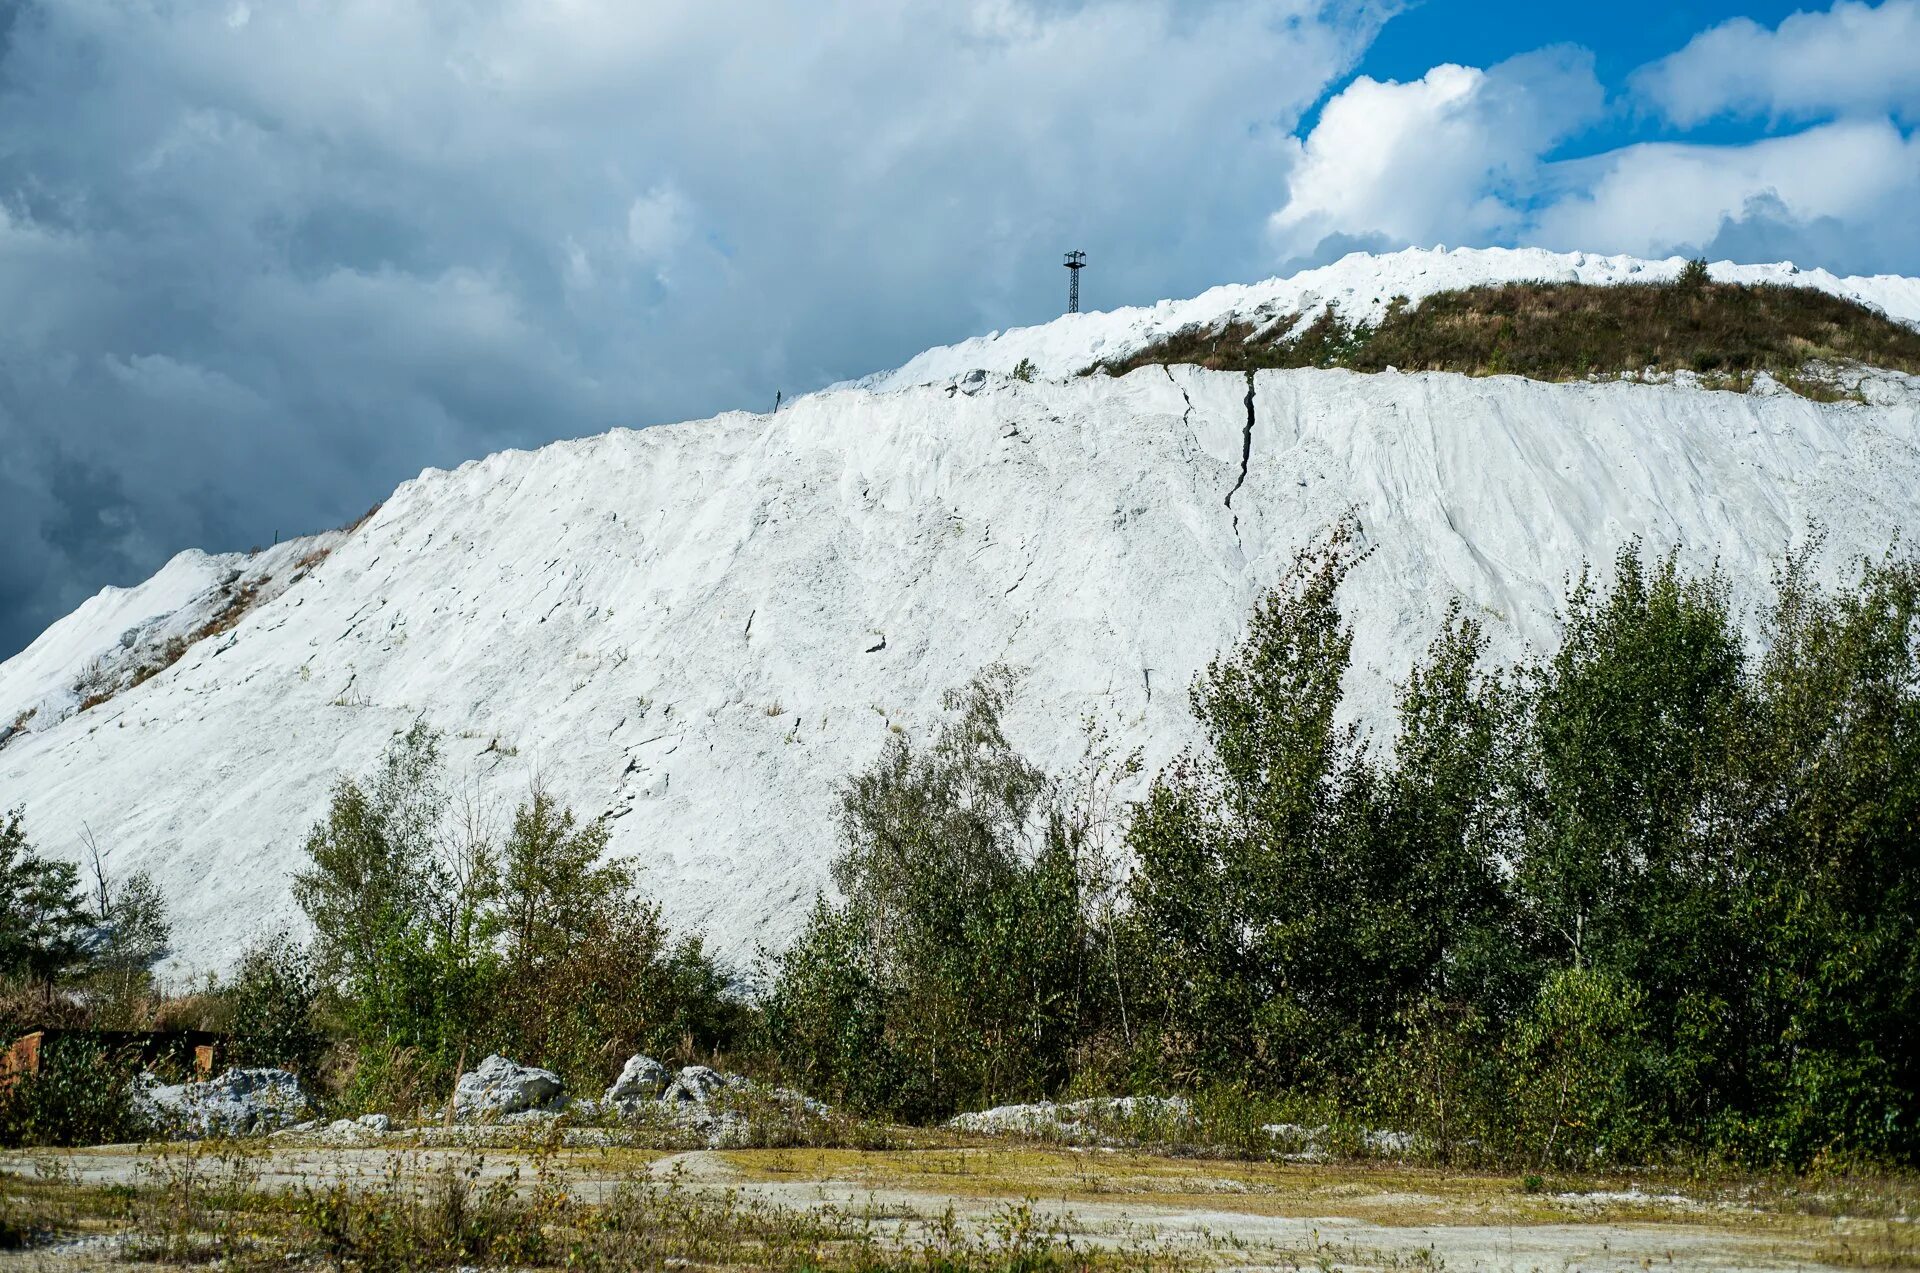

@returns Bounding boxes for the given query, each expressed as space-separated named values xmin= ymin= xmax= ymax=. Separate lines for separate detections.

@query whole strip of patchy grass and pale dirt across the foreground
xmin=0 ymin=1133 xmax=1920 ymax=1269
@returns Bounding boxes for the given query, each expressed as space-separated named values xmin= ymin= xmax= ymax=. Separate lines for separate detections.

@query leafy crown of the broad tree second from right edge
xmin=1519 ymin=545 xmax=1751 ymax=995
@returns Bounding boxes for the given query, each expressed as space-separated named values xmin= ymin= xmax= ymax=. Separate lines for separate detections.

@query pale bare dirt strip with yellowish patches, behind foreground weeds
xmin=0 ymin=1141 xmax=1920 ymax=1269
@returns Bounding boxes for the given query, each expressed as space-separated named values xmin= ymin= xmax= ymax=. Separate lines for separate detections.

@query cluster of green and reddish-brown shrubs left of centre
xmin=291 ymin=724 xmax=741 ymax=1108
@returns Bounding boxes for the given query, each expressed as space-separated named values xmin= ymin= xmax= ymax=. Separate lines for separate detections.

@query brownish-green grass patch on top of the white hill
xmin=1089 ymin=282 xmax=1920 ymax=397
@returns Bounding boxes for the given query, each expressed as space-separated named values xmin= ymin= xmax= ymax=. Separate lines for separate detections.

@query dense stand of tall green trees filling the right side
xmin=1129 ymin=524 xmax=1920 ymax=1165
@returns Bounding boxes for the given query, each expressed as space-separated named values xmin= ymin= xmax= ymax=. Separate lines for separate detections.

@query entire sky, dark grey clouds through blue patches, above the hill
xmin=0 ymin=0 xmax=1920 ymax=657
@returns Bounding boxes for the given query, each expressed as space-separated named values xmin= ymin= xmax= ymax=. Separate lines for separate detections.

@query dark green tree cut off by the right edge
xmin=1740 ymin=540 xmax=1920 ymax=1162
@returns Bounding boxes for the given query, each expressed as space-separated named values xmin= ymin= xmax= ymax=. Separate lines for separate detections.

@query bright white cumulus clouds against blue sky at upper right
xmin=1269 ymin=0 xmax=1920 ymax=273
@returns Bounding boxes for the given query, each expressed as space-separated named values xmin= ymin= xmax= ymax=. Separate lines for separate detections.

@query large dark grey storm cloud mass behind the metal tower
xmin=0 ymin=0 xmax=1375 ymax=657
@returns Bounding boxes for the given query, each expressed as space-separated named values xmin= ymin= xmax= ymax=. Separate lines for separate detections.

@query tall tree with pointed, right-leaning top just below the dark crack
xmin=1129 ymin=518 xmax=1394 ymax=1083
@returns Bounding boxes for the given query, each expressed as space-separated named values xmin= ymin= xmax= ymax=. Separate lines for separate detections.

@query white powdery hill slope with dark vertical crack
xmin=11 ymin=243 xmax=1920 ymax=968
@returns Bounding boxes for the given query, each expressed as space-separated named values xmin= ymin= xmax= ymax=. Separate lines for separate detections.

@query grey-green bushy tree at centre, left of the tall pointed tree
xmin=764 ymin=668 xmax=1114 ymax=1117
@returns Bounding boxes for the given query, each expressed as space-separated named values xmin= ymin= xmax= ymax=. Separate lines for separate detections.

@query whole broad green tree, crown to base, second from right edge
xmin=1515 ymin=543 xmax=1759 ymax=1129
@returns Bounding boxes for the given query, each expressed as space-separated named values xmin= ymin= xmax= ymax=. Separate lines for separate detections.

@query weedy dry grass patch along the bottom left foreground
xmin=0 ymin=1146 xmax=1188 ymax=1273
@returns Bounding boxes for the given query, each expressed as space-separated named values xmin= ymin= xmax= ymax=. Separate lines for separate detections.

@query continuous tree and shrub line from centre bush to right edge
xmin=766 ymin=524 xmax=1920 ymax=1164
